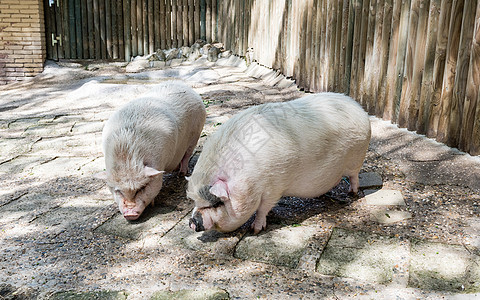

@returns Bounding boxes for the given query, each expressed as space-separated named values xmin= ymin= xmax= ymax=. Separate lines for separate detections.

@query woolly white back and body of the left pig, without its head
xmin=103 ymin=82 xmax=205 ymax=171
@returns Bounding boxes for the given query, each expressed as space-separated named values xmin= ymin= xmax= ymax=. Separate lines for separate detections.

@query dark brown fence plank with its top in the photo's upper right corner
xmin=446 ymin=0 xmax=477 ymax=147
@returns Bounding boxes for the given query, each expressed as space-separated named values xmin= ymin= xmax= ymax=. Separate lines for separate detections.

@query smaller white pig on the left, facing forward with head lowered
xmin=97 ymin=81 xmax=206 ymax=220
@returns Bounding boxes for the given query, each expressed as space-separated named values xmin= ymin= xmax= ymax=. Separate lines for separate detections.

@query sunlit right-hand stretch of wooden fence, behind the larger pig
xmin=219 ymin=0 xmax=480 ymax=155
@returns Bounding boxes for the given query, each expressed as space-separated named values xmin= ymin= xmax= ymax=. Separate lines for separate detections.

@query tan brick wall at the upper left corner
xmin=0 ymin=0 xmax=46 ymax=85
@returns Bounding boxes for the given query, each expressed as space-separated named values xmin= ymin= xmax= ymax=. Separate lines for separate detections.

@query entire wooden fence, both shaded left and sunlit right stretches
xmin=45 ymin=0 xmax=480 ymax=155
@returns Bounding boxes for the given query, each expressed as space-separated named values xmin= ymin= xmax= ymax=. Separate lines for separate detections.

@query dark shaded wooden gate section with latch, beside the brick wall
xmin=44 ymin=0 xmax=218 ymax=60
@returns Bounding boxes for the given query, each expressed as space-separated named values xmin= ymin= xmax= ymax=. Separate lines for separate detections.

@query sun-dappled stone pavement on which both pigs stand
xmin=0 ymin=56 xmax=480 ymax=299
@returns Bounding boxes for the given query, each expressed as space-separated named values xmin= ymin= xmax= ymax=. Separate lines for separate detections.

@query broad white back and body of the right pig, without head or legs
xmin=197 ymin=93 xmax=370 ymax=197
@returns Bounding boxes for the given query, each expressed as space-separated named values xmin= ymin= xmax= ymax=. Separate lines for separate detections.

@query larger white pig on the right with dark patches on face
xmin=187 ymin=93 xmax=370 ymax=234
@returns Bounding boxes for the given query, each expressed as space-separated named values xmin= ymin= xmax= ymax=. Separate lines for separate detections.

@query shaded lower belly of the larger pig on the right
xmin=283 ymin=165 xmax=343 ymax=198
